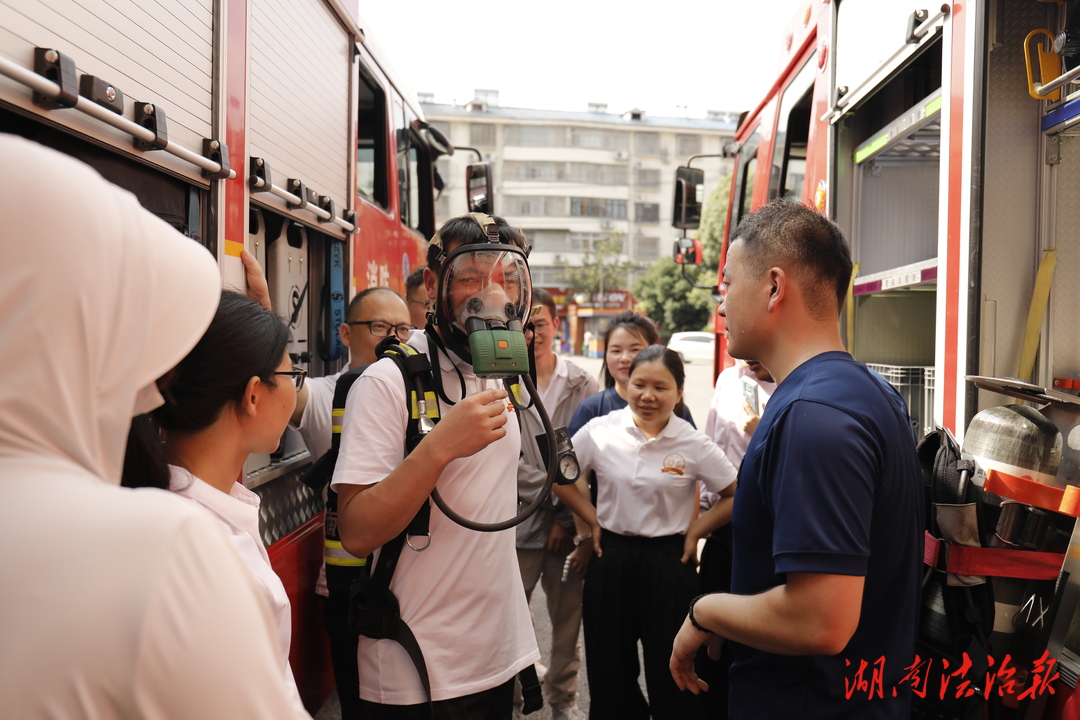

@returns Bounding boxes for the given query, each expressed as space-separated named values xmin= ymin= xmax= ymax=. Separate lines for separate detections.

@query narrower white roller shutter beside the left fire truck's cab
xmin=248 ymin=0 xmax=354 ymax=227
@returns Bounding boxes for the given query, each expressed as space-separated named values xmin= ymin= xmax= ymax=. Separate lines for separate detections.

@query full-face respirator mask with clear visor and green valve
xmin=436 ymin=213 xmax=532 ymax=378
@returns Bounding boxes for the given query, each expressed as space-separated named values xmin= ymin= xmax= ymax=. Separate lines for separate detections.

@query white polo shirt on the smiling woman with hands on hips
xmin=572 ymin=407 xmax=735 ymax=538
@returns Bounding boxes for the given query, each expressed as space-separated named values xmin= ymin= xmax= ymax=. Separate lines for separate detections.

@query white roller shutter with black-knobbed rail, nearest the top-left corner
xmin=0 ymin=0 xmax=214 ymax=185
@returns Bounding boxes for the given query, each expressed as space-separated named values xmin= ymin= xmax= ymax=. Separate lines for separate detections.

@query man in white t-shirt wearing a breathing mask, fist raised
xmin=333 ymin=216 xmax=540 ymax=720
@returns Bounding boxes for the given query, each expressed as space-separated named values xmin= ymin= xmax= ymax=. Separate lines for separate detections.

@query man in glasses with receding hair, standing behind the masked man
xmin=289 ymin=287 xmax=413 ymax=718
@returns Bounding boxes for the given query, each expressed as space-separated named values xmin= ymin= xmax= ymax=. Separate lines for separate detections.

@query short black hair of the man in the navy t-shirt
xmin=731 ymin=200 xmax=851 ymax=317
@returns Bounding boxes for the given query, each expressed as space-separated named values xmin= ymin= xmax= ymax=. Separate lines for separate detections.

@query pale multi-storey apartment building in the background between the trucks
xmin=420 ymin=90 xmax=738 ymax=290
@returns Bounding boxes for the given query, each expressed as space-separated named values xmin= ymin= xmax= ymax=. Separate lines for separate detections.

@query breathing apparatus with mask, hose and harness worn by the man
xmin=305 ymin=214 xmax=578 ymax=715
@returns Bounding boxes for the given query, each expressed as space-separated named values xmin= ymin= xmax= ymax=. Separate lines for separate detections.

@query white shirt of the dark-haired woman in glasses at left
xmin=168 ymin=465 xmax=296 ymax=685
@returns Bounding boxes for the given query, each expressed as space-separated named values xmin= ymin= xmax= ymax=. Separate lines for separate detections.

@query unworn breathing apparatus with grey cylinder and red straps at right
xmin=914 ymin=378 xmax=1080 ymax=720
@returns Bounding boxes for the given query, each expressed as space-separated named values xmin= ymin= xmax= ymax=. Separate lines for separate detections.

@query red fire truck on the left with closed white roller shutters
xmin=0 ymin=0 xmax=483 ymax=709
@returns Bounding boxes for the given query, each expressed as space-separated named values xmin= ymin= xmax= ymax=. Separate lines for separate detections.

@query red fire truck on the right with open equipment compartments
xmin=675 ymin=0 xmax=1080 ymax=718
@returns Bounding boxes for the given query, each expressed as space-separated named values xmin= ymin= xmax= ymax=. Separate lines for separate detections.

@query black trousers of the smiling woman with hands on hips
xmin=582 ymin=531 xmax=698 ymax=720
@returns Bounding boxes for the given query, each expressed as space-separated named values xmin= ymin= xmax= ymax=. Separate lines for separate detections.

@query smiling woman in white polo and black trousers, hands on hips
xmin=556 ymin=345 xmax=735 ymax=720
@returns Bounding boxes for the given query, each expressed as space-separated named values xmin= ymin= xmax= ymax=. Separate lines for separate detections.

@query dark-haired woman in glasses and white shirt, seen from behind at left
xmin=122 ymin=290 xmax=306 ymax=688
